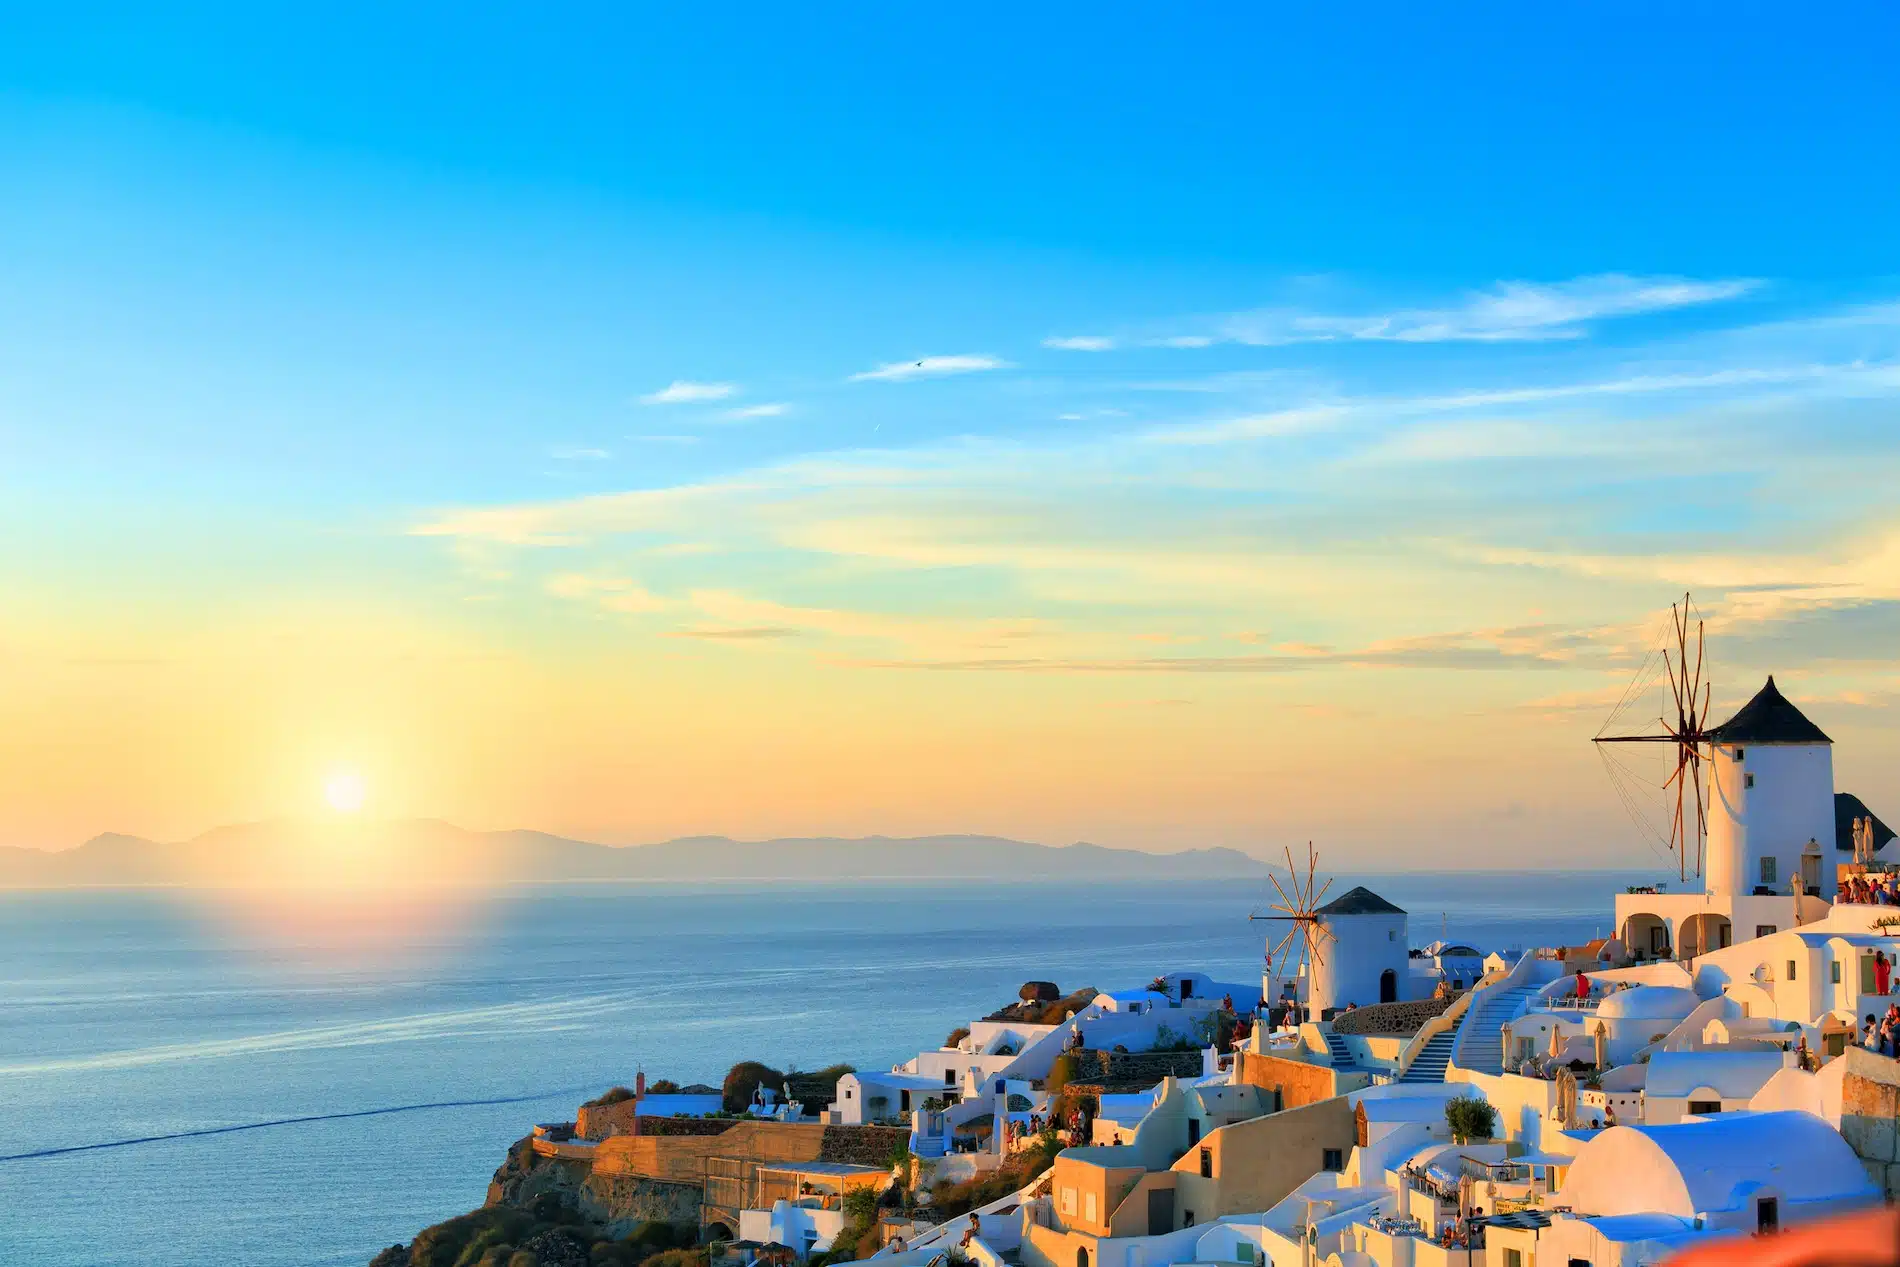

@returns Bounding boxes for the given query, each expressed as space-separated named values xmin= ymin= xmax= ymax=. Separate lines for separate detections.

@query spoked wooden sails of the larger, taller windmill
xmin=1592 ymin=595 xmax=1710 ymax=879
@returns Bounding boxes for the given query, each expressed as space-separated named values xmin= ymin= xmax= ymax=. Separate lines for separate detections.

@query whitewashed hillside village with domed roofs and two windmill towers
xmin=505 ymin=678 xmax=1900 ymax=1267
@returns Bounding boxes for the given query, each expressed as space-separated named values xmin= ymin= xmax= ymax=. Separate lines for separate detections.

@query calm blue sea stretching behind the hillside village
xmin=0 ymin=874 xmax=1651 ymax=1267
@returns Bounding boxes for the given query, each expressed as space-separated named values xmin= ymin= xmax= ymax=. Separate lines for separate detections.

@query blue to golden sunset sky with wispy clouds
xmin=0 ymin=4 xmax=1900 ymax=868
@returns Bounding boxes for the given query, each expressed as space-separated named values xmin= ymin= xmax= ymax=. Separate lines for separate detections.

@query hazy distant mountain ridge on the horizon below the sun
xmin=0 ymin=819 xmax=1267 ymax=887
